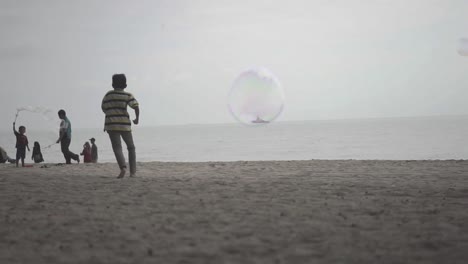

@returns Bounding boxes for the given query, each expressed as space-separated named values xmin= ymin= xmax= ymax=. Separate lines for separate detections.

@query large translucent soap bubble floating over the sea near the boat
xmin=228 ymin=67 xmax=284 ymax=125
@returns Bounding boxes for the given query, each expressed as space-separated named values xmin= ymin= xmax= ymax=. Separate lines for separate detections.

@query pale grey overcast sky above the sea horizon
xmin=0 ymin=0 xmax=468 ymax=128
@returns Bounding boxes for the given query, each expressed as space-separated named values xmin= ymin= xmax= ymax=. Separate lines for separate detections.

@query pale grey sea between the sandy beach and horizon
xmin=0 ymin=116 xmax=468 ymax=163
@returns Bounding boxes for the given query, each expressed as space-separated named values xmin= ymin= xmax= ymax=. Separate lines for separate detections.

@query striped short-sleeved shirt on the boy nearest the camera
xmin=101 ymin=89 xmax=138 ymax=131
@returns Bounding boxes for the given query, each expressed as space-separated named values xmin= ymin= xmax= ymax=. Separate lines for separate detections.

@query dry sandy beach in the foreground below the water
xmin=0 ymin=160 xmax=468 ymax=263
